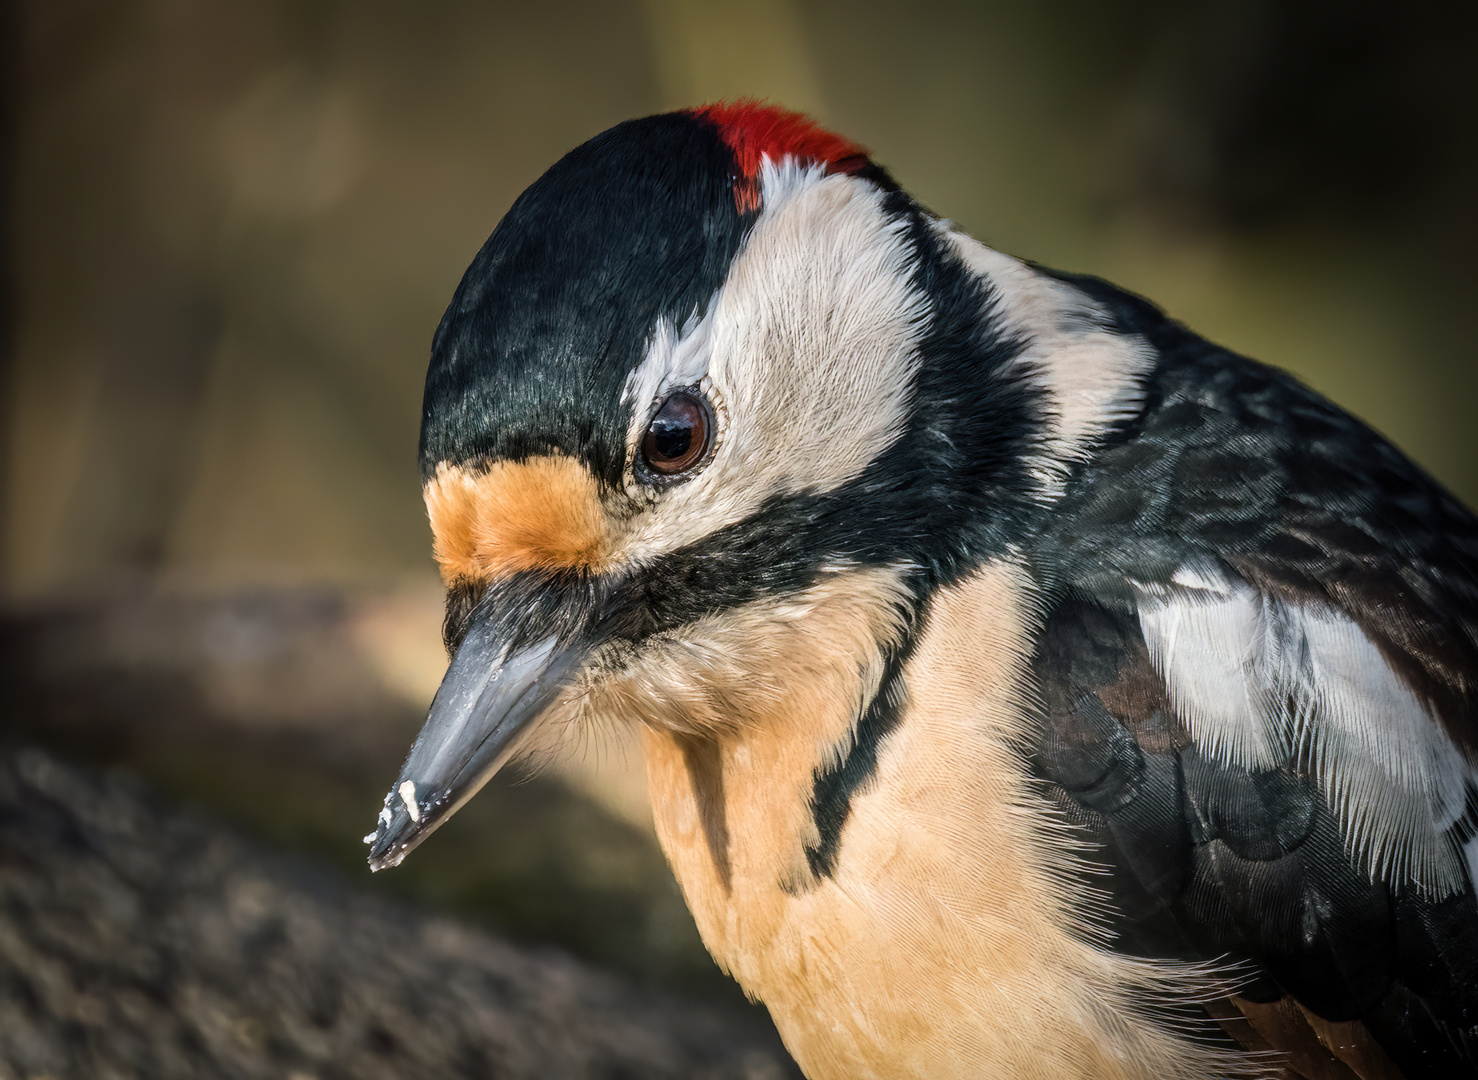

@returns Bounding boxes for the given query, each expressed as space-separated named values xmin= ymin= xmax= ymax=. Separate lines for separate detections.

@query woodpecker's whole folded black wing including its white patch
xmin=1035 ymin=319 xmax=1478 ymax=1077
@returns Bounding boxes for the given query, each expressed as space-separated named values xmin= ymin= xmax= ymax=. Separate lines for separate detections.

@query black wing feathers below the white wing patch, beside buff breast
xmin=1035 ymin=600 xmax=1478 ymax=1077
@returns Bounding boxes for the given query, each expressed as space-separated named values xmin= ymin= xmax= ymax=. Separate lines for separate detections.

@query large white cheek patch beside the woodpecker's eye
xmin=621 ymin=164 xmax=928 ymax=561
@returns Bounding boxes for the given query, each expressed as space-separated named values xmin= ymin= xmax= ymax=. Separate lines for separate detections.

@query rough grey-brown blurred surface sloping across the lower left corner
xmin=0 ymin=751 xmax=795 ymax=1080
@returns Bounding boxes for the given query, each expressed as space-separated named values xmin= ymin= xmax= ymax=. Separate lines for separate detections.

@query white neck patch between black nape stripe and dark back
xmin=940 ymin=234 xmax=1156 ymax=498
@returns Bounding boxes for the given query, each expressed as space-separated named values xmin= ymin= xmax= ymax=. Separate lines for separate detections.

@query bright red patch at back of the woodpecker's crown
xmin=689 ymin=99 xmax=871 ymax=213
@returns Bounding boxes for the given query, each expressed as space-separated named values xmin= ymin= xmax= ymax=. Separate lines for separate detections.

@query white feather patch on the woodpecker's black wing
xmin=1140 ymin=570 xmax=1478 ymax=897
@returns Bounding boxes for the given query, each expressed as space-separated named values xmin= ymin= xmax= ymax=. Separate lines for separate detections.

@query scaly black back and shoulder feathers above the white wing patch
xmin=1048 ymin=267 xmax=1478 ymax=756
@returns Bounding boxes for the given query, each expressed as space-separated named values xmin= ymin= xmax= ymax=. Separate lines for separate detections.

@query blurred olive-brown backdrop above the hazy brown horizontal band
xmin=4 ymin=0 xmax=1478 ymax=594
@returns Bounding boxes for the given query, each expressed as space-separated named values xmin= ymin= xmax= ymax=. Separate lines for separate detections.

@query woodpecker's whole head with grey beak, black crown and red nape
xmin=367 ymin=103 xmax=1135 ymax=869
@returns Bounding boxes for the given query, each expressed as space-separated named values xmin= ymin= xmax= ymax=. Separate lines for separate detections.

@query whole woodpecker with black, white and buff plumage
xmin=367 ymin=102 xmax=1478 ymax=1080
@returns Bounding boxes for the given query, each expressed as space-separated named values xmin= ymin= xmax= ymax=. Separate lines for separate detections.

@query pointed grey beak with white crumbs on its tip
xmin=365 ymin=616 xmax=588 ymax=870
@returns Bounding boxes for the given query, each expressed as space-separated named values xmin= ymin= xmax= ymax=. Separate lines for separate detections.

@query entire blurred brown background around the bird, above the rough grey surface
xmin=0 ymin=0 xmax=1478 ymax=1022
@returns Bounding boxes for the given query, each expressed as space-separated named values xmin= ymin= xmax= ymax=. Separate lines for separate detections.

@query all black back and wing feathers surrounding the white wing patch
xmin=1033 ymin=271 xmax=1478 ymax=1077
